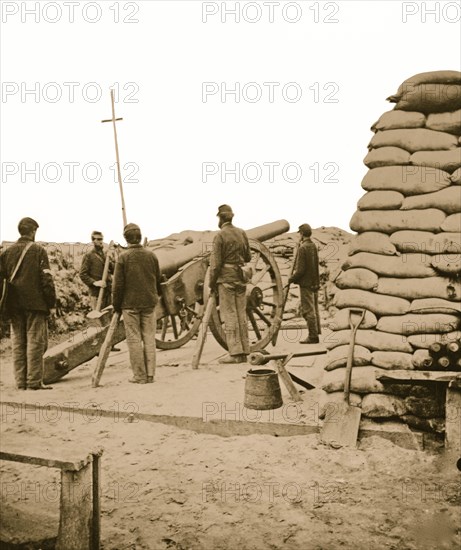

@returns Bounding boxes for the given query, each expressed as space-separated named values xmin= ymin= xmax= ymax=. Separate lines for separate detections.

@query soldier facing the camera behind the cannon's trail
xmin=80 ymin=231 xmax=114 ymax=309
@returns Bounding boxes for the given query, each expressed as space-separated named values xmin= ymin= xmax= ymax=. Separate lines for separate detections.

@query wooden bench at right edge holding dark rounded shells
xmin=377 ymin=370 xmax=461 ymax=458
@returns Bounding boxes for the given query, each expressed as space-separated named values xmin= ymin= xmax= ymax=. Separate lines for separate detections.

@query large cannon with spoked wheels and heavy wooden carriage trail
xmin=44 ymin=220 xmax=290 ymax=383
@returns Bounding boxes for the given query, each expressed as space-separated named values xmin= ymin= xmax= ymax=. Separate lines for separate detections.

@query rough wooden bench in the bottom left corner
xmin=0 ymin=446 xmax=102 ymax=550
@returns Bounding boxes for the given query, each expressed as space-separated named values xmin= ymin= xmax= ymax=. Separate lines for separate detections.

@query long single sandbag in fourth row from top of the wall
xmin=368 ymin=128 xmax=458 ymax=153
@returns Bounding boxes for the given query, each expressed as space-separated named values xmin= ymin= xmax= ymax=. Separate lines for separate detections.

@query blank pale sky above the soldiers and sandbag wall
xmin=0 ymin=0 xmax=461 ymax=243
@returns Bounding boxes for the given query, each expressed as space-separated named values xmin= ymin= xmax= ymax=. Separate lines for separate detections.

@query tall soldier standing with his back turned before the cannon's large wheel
xmin=210 ymin=204 xmax=251 ymax=363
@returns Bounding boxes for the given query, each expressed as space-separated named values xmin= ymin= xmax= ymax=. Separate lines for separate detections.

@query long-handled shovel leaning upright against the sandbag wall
xmin=320 ymin=309 xmax=365 ymax=448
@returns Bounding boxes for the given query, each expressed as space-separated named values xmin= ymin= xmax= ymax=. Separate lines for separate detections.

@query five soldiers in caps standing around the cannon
xmin=0 ymin=205 xmax=320 ymax=390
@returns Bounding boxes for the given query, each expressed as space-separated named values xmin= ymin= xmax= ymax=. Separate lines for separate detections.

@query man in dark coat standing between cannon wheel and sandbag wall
xmin=289 ymin=223 xmax=320 ymax=344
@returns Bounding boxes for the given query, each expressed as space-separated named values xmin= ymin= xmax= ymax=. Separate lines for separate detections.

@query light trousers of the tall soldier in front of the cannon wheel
xmin=218 ymin=283 xmax=250 ymax=355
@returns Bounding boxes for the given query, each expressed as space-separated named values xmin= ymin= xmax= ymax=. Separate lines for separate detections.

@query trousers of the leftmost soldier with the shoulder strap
xmin=11 ymin=310 xmax=48 ymax=388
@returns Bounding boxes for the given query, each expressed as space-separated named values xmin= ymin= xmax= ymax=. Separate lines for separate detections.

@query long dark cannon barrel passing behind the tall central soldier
xmin=153 ymin=220 xmax=290 ymax=278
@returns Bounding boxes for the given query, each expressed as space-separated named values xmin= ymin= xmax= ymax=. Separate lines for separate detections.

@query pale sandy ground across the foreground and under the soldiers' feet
xmin=0 ymin=330 xmax=461 ymax=550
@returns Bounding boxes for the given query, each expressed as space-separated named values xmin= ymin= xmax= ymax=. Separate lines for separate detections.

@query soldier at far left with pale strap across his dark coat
xmin=0 ymin=218 xmax=56 ymax=390
